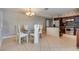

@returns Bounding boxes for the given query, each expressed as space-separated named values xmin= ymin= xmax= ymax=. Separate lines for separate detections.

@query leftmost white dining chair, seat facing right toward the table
xmin=16 ymin=25 xmax=28 ymax=44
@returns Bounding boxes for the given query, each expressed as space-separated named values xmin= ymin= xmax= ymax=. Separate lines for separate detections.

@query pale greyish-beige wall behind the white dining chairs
xmin=2 ymin=11 xmax=44 ymax=36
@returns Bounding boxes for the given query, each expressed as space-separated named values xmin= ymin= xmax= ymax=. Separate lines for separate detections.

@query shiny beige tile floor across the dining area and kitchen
xmin=0 ymin=34 xmax=79 ymax=51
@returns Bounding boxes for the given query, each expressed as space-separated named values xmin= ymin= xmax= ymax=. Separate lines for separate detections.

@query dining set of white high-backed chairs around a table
xmin=15 ymin=24 xmax=43 ymax=44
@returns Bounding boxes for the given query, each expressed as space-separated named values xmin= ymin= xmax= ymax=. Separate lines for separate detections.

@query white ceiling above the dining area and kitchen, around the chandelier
xmin=2 ymin=8 xmax=75 ymax=17
